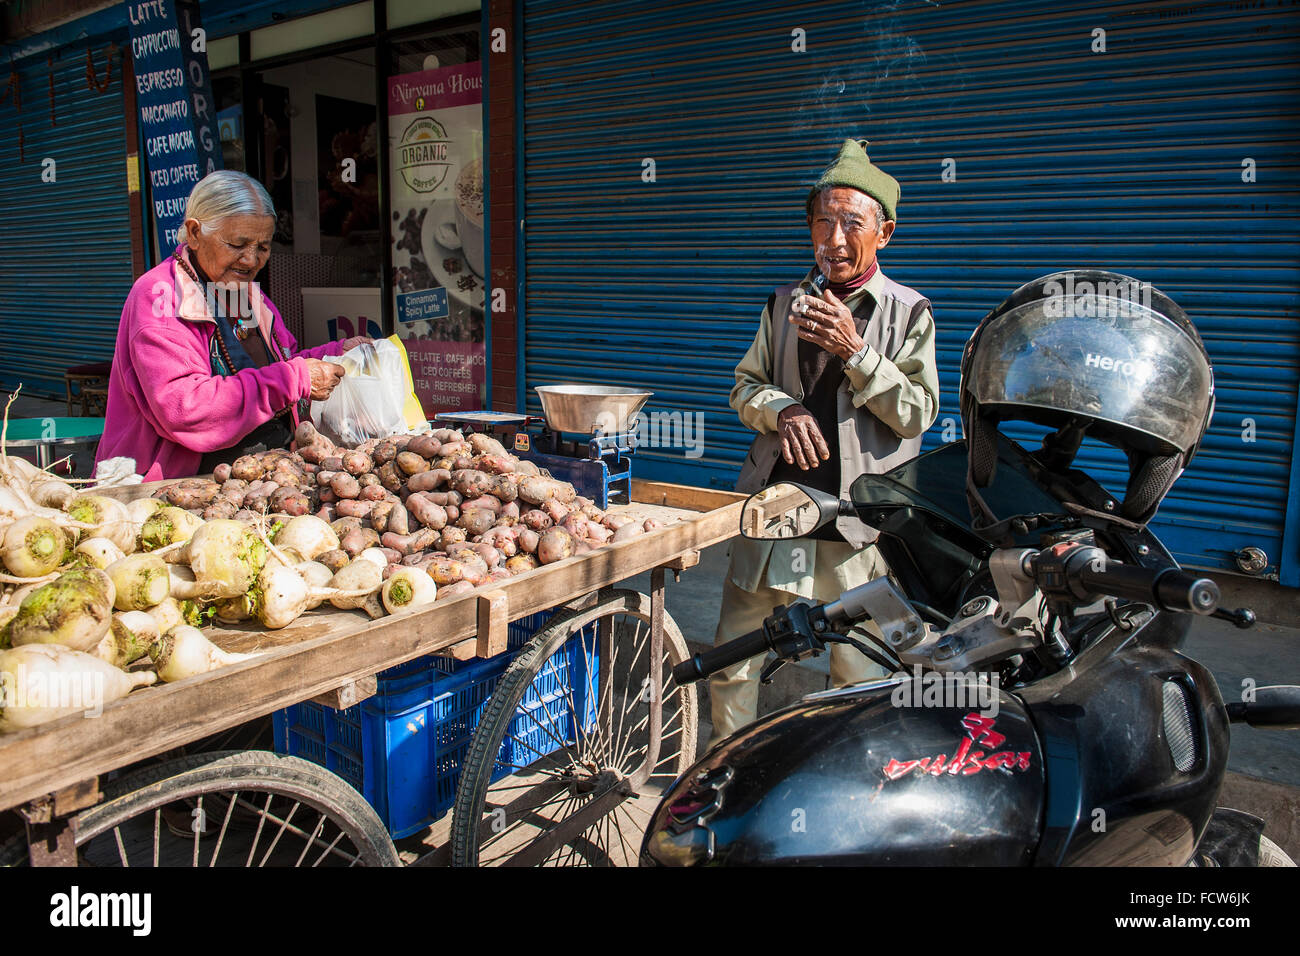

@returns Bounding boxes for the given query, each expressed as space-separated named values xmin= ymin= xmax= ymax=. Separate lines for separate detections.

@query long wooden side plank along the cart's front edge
xmin=0 ymin=479 xmax=744 ymax=809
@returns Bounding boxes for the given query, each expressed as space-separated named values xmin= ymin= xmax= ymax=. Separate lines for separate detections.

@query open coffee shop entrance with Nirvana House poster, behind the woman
xmin=205 ymin=17 xmax=490 ymax=416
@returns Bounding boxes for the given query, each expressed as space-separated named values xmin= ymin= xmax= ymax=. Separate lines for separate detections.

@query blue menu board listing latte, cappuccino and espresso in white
xmin=126 ymin=0 xmax=222 ymax=256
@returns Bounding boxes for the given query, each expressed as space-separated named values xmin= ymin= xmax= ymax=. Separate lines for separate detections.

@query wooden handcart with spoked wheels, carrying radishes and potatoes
xmin=0 ymin=480 xmax=744 ymax=866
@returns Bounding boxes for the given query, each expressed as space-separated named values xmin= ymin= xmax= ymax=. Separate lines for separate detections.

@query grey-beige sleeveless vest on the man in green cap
xmin=736 ymin=278 xmax=930 ymax=548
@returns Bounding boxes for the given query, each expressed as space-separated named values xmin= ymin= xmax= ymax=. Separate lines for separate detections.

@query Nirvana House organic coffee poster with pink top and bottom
xmin=389 ymin=62 xmax=486 ymax=415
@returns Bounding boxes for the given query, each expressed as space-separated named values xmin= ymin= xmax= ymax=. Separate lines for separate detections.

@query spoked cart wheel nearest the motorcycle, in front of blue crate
xmin=451 ymin=589 xmax=698 ymax=866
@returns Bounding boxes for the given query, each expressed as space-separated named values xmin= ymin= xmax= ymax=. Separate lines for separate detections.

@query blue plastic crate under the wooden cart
xmin=273 ymin=611 xmax=598 ymax=838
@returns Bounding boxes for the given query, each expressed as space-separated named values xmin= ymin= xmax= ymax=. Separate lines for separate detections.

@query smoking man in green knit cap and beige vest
xmin=711 ymin=139 xmax=939 ymax=743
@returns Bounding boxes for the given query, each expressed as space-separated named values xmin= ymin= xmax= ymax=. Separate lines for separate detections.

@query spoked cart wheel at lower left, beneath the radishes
xmin=0 ymin=750 xmax=400 ymax=866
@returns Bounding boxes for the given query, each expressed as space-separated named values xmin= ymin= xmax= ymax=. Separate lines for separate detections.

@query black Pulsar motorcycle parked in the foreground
xmin=640 ymin=433 xmax=1300 ymax=866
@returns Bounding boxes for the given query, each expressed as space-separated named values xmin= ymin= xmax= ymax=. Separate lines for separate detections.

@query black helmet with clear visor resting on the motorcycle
xmin=961 ymin=269 xmax=1214 ymax=524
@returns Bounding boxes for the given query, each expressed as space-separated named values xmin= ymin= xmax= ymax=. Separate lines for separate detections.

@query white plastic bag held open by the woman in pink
xmin=312 ymin=338 xmax=410 ymax=447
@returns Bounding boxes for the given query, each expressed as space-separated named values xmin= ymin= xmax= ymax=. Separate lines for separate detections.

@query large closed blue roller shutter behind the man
xmin=523 ymin=0 xmax=1300 ymax=585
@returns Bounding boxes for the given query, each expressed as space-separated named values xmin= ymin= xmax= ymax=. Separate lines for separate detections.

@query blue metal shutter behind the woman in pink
xmin=0 ymin=36 xmax=133 ymax=397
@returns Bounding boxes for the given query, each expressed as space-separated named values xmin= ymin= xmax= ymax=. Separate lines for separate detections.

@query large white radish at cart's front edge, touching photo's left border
xmin=0 ymin=644 xmax=157 ymax=731
